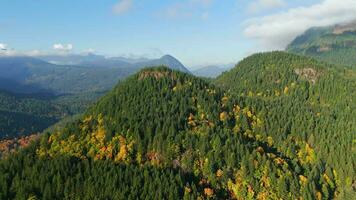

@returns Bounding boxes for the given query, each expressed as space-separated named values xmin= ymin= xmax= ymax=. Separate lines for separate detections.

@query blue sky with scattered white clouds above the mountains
xmin=0 ymin=0 xmax=356 ymax=67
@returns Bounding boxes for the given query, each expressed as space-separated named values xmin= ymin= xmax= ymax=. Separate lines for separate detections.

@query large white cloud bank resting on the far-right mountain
xmin=244 ymin=0 xmax=356 ymax=50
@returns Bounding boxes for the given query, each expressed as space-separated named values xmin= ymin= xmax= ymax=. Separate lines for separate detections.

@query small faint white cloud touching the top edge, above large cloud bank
xmin=247 ymin=0 xmax=286 ymax=13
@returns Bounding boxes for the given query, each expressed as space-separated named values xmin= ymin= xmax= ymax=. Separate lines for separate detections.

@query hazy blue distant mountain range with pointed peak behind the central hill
xmin=0 ymin=54 xmax=190 ymax=94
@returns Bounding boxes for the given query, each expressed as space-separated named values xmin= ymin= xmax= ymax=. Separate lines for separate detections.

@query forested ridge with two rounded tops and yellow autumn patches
xmin=0 ymin=52 xmax=356 ymax=199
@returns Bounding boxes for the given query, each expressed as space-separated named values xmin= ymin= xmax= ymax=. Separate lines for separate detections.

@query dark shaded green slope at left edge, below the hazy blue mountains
xmin=0 ymin=91 xmax=101 ymax=139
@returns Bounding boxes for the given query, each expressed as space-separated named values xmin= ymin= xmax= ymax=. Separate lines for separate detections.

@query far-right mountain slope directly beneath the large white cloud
xmin=287 ymin=22 xmax=356 ymax=68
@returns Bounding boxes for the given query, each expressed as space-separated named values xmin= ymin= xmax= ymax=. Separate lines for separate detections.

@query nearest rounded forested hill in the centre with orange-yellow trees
xmin=0 ymin=68 xmax=330 ymax=199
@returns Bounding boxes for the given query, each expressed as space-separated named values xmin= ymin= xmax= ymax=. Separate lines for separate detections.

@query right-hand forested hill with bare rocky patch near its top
xmin=215 ymin=52 xmax=356 ymax=199
